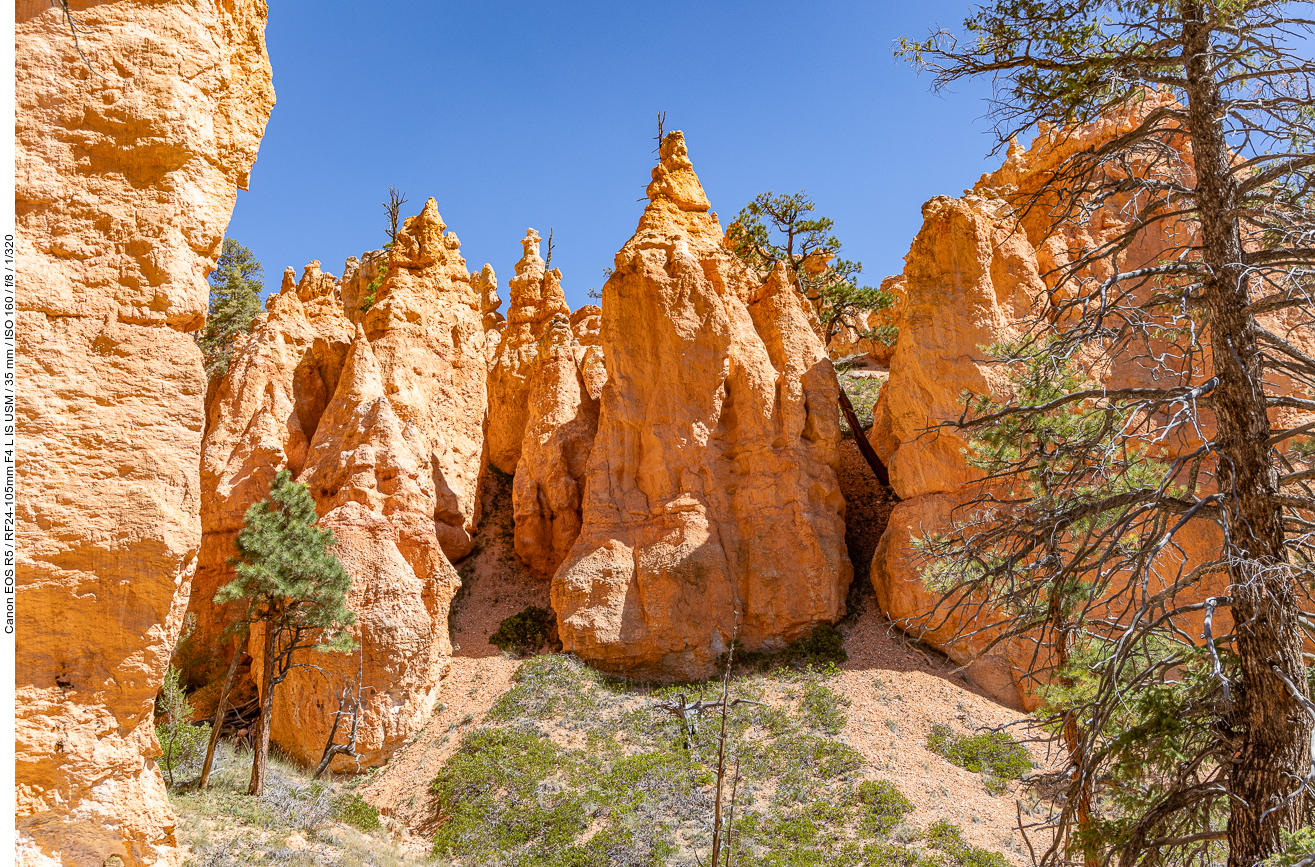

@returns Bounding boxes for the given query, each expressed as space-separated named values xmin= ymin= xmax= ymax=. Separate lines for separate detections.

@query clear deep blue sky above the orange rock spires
xmin=229 ymin=0 xmax=998 ymax=308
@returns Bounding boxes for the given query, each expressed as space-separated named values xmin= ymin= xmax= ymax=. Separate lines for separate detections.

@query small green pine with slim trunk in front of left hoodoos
xmin=214 ymin=470 xmax=356 ymax=795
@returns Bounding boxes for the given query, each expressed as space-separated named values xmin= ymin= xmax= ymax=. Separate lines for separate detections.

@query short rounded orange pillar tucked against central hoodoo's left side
xmin=512 ymin=313 xmax=598 ymax=578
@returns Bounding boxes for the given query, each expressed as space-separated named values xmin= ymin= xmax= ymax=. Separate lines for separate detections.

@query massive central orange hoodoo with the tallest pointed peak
xmin=551 ymin=133 xmax=852 ymax=678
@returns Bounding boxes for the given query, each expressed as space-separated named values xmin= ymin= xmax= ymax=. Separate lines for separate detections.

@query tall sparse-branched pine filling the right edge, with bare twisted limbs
xmin=897 ymin=0 xmax=1315 ymax=867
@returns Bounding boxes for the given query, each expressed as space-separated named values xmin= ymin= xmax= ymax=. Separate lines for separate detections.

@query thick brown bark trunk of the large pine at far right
xmin=1184 ymin=3 xmax=1311 ymax=867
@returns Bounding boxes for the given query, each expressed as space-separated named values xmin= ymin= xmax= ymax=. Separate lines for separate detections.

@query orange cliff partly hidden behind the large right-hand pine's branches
xmin=869 ymin=104 xmax=1236 ymax=708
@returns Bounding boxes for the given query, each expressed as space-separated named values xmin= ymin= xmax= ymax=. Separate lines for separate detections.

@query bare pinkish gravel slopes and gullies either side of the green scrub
xmin=360 ymin=439 xmax=1044 ymax=864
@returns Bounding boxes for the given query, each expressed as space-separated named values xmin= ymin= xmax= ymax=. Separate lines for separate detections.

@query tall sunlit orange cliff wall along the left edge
xmin=14 ymin=0 xmax=274 ymax=867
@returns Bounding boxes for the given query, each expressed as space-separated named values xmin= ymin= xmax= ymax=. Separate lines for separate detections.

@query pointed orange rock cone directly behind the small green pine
xmin=259 ymin=325 xmax=460 ymax=772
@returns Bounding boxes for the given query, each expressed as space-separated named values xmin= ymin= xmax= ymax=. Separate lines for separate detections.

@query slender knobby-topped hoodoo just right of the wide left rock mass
xmin=488 ymin=229 xmax=571 ymax=475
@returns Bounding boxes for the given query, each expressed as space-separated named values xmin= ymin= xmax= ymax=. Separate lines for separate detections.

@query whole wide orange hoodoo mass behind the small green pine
xmin=187 ymin=205 xmax=497 ymax=771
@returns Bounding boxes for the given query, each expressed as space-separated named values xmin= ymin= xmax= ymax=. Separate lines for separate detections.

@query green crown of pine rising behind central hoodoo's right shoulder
xmin=726 ymin=191 xmax=896 ymax=346
